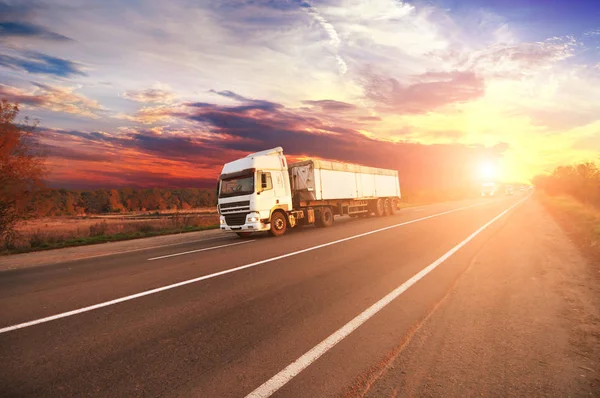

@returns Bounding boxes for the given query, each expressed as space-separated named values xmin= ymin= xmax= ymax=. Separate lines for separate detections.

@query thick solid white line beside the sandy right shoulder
xmin=246 ymin=198 xmax=527 ymax=398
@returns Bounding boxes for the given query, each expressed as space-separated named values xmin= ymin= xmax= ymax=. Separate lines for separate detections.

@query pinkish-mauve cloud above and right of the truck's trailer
xmin=362 ymin=71 xmax=485 ymax=114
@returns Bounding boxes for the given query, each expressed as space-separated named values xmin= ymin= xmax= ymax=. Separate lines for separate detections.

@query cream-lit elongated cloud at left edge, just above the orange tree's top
xmin=0 ymin=83 xmax=104 ymax=119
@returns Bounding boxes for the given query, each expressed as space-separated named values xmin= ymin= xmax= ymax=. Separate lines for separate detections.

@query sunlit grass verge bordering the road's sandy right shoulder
xmin=537 ymin=192 xmax=600 ymax=261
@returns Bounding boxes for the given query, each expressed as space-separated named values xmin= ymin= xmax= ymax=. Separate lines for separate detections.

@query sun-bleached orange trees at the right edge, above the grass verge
xmin=533 ymin=162 xmax=600 ymax=208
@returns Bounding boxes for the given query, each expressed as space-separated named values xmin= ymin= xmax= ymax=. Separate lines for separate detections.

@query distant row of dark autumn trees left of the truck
xmin=27 ymin=188 xmax=217 ymax=217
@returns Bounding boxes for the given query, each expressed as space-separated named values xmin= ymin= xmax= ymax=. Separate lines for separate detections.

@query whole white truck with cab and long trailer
xmin=217 ymin=147 xmax=400 ymax=237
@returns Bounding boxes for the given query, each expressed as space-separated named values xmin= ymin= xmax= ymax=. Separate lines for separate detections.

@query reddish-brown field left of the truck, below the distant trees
xmin=5 ymin=208 xmax=219 ymax=253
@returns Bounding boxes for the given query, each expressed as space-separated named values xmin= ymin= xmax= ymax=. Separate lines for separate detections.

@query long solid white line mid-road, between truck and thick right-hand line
xmin=0 ymin=202 xmax=490 ymax=334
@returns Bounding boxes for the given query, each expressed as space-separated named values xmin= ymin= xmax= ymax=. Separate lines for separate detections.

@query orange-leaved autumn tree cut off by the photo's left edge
xmin=0 ymin=100 xmax=44 ymax=245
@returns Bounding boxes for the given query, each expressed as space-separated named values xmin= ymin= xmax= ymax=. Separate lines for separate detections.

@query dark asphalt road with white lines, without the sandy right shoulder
xmin=0 ymin=195 xmax=596 ymax=397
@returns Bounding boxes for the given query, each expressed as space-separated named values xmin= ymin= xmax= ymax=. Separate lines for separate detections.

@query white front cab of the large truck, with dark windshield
xmin=217 ymin=147 xmax=292 ymax=236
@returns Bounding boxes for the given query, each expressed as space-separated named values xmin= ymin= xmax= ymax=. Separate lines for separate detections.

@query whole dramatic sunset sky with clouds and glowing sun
xmin=0 ymin=0 xmax=600 ymax=188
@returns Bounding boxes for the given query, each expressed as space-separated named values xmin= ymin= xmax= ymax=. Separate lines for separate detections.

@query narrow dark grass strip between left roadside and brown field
xmin=0 ymin=225 xmax=219 ymax=255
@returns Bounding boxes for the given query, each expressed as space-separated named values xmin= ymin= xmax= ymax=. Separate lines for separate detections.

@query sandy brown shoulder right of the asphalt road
xmin=361 ymin=200 xmax=600 ymax=397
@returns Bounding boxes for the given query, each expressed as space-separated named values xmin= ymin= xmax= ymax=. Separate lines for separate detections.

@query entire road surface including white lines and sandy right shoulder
xmin=0 ymin=196 xmax=600 ymax=397
